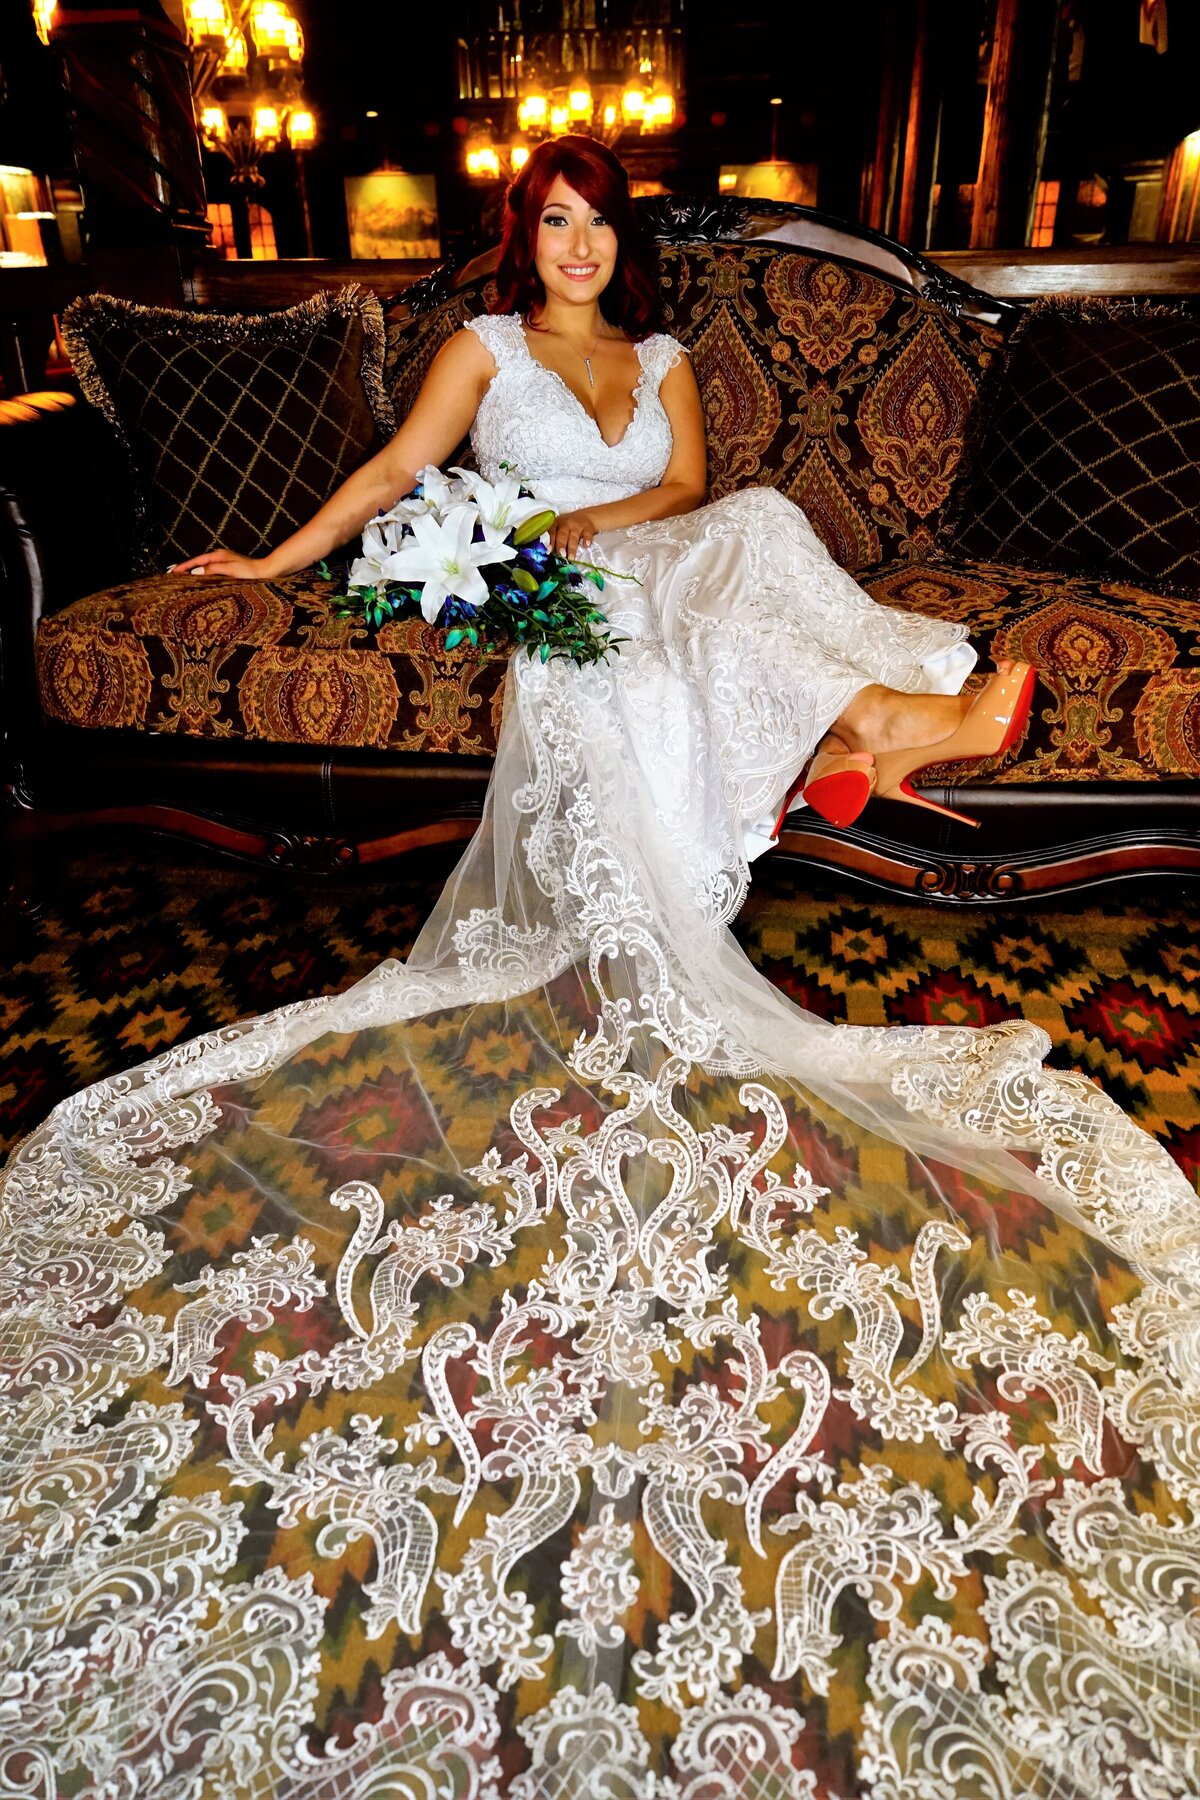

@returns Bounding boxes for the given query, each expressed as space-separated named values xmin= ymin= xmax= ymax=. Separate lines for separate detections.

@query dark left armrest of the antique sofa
xmin=0 ymin=391 xmax=133 ymax=781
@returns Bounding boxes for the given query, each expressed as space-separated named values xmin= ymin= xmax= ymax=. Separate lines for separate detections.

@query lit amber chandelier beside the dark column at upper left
xmin=184 ymin=0 xmax=317 ymax=187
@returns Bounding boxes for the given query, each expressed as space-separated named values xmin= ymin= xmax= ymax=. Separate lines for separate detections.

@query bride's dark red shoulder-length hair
xmin=495 ymin=135 xmax=658 ymax=340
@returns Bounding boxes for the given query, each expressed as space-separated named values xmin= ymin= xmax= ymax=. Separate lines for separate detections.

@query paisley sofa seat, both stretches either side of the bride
xmin=38 ymin=558 xmax=1200 ymax=783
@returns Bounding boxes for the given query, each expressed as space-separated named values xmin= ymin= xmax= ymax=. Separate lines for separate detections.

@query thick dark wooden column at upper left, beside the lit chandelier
xmin=52 ymin=0 xmax=209 ymax=304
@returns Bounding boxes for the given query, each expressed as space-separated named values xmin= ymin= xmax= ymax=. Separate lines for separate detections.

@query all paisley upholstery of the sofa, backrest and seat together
xmin=38 ymin=243 xmax=1200 ymax=785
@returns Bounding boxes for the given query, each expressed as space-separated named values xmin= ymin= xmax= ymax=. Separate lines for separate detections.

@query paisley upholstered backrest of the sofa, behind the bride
xmin=385 ymin=245 xmax=1004 ymax=569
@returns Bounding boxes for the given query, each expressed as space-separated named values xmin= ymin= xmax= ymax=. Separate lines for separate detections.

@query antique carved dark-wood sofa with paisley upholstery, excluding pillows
xmin=0 ymin=200 xmax=1200 ymax=904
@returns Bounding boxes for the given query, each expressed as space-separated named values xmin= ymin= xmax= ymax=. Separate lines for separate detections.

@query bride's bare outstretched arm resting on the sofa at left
xmin=173 ymin=329 xmax=495 ymax=580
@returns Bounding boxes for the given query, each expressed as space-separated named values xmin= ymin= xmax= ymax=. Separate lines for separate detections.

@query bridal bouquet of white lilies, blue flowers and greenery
xmin=320 ymin=463 xmax=637 ymax=664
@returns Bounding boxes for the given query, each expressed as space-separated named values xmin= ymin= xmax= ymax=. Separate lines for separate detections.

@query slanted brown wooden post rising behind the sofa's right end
xmin=972 ymin=0 xmax=1058 ymax=250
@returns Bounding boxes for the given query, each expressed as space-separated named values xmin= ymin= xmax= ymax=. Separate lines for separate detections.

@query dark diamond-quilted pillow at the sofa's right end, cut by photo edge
xmin=943 ymin=297 xmax=1200 ymax=594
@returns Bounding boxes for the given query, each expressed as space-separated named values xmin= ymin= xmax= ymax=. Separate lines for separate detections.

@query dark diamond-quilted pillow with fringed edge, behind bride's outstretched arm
xmin=63 ymin=284 xmax=394 ymax=572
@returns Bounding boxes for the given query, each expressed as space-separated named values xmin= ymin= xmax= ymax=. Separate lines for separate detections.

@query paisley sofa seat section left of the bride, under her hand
xmin=38 ymin=569 xmax=507 ymax=756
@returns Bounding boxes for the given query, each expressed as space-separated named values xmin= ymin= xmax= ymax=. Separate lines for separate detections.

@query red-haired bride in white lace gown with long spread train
xmin=9 ymin=139 xmax=1200 ymax=1800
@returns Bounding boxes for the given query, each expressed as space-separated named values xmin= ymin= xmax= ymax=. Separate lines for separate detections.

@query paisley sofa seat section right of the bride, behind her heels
xmin=864 ymin=556 xmax=1200 ymax=785
